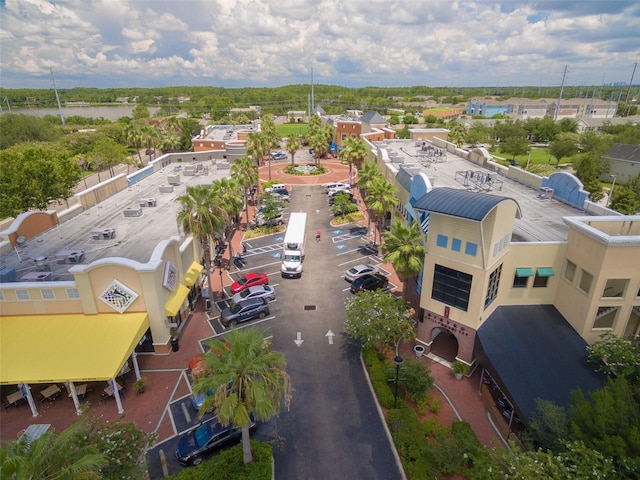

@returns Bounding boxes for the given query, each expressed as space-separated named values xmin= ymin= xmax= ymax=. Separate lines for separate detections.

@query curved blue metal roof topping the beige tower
xmin=413 ymin=187 xmax=520 ymax=222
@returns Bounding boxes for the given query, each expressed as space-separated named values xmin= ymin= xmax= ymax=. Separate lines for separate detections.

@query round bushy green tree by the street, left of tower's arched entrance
xmin=344 ymin=290 xmax=416 ymax=352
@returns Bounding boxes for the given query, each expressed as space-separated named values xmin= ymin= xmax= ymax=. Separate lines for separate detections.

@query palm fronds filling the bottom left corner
xmin=0 ymin=422 xmax=107 ymax=480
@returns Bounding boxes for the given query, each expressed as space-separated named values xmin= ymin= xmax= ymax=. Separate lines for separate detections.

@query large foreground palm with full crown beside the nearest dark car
xmin=193 ymin=328 xmax=291 ymax=465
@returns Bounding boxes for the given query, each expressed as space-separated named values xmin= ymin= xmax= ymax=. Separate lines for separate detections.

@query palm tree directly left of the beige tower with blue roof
xmin=381 ymin=219 xmax=425 ymax=301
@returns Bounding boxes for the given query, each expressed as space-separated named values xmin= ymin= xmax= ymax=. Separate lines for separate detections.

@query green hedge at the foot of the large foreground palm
xmin=168 ymin=440 xmax=273 ymax=480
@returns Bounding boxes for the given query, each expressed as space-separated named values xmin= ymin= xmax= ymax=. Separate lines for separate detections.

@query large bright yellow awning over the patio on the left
xmin=0 ymin=312 xmax=149 ymax=385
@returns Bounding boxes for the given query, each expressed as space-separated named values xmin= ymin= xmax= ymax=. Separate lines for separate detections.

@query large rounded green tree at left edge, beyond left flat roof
xmin=0 ymin=144 xmax=82 ymax=218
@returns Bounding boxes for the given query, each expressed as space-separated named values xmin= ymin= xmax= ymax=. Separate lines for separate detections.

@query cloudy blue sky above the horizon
xmin=0 ymin=0 xmax=640 ymax=88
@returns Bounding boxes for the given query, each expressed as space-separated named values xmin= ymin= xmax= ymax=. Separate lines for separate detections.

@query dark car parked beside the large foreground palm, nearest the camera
xmin=176 ymin=416 xmax=257 ymax=466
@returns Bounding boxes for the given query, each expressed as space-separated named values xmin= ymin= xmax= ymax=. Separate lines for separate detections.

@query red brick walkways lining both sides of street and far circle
xmin=0 ymin=159 xmax=508 ymax=454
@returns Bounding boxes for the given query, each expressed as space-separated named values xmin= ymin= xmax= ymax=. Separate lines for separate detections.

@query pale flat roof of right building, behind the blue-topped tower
xmin=374 ymin=139 xmax=589 ymax=242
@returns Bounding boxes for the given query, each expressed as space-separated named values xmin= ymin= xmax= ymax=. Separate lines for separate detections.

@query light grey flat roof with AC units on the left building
xmin=0 ymin=160 xmax=230 ymax=288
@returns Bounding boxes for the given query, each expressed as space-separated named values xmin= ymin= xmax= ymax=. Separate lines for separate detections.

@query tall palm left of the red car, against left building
xmin=176 ymin=185 xmax=227 ymax=304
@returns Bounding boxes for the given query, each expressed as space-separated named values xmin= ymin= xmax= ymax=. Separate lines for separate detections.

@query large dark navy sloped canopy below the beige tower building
xmin=475 ymin=305 xmax=604 ymax=420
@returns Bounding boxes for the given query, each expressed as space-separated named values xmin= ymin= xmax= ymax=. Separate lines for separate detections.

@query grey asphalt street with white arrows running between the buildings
xmin=149 ymin=185 xmax=402 ymax=480
